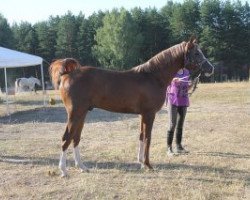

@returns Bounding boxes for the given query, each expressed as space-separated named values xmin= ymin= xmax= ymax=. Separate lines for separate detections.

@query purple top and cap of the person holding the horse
xmin=166 ymin=69 xmax=189 ymax=106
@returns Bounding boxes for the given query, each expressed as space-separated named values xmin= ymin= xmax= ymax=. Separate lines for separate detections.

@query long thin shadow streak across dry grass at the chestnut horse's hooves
xmin=0 ymin=156 xmax=250 ymax=181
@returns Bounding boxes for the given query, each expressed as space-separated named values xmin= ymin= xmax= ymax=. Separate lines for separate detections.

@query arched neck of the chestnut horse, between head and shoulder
xmin=147 ymin=42 xmax=186 ymax=87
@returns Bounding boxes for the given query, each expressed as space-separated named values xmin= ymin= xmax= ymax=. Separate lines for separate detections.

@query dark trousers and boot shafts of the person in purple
xmin=167 ymin=104 xmax=187 ymax=147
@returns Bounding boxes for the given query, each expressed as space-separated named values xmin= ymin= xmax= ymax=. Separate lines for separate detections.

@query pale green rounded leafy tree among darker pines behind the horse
xmin=93 ymin=9 xmax=142 ymax=69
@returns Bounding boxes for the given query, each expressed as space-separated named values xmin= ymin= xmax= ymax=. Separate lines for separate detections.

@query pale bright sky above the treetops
xmin=0 ymin=0 xmax=176 ymax=25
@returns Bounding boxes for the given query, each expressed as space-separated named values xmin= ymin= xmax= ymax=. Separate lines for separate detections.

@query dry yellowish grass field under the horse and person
xmin=0 ymin=83 xmax=250 ymax=200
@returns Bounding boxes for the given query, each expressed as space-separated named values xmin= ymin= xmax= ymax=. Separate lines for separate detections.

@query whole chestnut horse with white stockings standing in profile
xmin=50 ymin=39 xmax=214 ymax=176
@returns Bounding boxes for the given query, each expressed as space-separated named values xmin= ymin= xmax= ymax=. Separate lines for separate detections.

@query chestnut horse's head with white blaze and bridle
xmin=184 ymin=37 xmax=214 ymax=77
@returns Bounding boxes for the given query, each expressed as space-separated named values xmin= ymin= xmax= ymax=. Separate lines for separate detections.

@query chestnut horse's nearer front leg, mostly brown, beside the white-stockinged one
xmin=142 ymin=113 xmax=155 ymax=169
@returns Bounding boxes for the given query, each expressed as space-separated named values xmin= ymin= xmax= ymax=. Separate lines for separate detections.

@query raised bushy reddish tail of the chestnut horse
xmin=49 ymin=58 xmax=81 ymax=89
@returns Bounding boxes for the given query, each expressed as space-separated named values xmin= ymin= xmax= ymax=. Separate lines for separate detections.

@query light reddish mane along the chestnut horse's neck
xmin=132 ymin=42 xmax=186 ymax=73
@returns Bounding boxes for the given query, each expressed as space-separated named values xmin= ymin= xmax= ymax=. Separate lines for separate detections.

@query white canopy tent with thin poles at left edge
xmin=0 ymin=47 xmax=45 ymax=115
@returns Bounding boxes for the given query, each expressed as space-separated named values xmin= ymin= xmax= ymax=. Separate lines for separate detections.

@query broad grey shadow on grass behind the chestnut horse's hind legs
xmin=0 ymin=107 xmax=138 ymax=124
